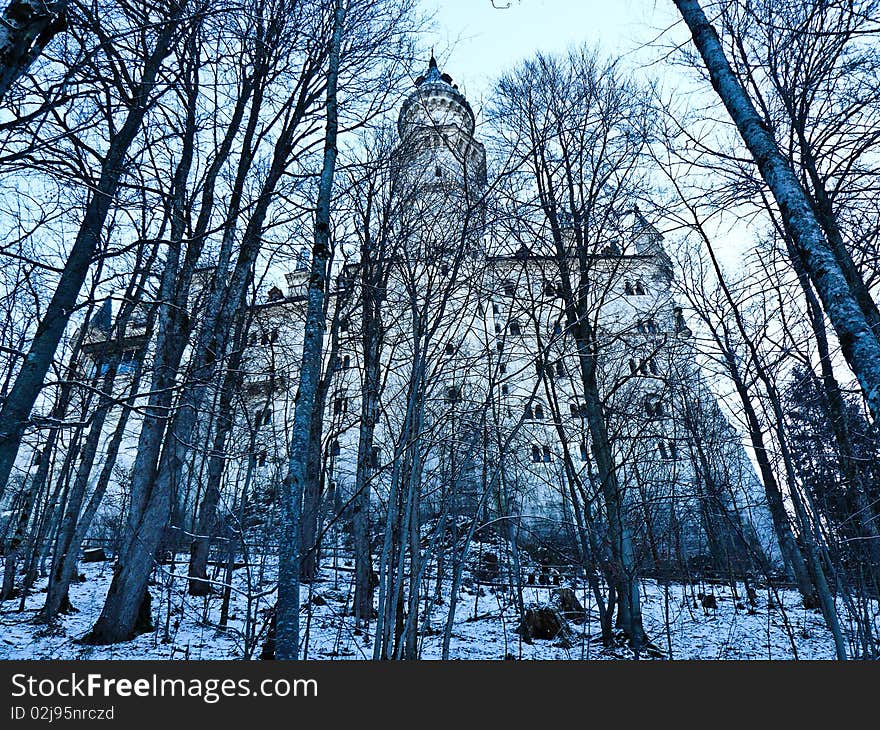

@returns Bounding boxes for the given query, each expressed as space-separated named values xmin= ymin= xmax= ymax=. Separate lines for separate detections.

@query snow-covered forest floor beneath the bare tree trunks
xmin=0 ymin=556 xmax=834 ymax=659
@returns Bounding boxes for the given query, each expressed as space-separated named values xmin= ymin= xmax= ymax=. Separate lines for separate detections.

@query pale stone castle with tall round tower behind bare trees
xmin=235 ymin=57 xmax=778 ymax=569
